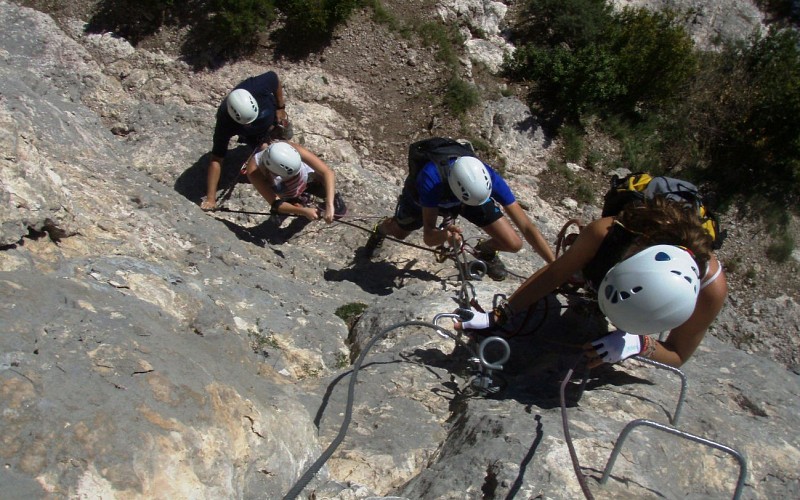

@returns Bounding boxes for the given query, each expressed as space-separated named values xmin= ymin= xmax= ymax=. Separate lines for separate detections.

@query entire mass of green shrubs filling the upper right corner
xmin=505 ymin=0 xmax=800 ymax=221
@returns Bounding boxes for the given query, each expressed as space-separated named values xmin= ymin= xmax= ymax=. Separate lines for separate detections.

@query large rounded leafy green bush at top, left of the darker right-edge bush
xmin=506 ymin=4 xmax=697 ymax=125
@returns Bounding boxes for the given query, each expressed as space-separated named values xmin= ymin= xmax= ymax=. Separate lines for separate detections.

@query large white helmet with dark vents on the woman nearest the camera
xmin=598 ymin=245 xmax=700 ymax=335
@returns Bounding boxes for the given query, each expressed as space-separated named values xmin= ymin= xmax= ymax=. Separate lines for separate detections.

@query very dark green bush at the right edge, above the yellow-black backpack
xmin=704 ymin=29 xmax=800 ymax=211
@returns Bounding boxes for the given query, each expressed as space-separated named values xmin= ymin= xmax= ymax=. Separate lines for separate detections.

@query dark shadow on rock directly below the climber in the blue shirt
xmin=323 ymin=259 xmax=441 ymax=296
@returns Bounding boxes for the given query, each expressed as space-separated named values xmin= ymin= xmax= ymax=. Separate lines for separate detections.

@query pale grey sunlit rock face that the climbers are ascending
xmin=0 ymin=2 xmax=800 ymax=499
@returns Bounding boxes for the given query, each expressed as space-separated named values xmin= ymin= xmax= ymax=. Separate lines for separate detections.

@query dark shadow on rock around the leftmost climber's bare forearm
xmin=173 ymin=145 xmax=252 ymax=205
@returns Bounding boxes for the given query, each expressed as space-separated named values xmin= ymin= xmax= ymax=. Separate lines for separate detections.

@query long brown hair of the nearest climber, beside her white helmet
xmin=617 ymin=198 xmax=712 ymax=274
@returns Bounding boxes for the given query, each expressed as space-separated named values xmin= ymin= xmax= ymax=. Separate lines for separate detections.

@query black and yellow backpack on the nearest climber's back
xmin=603 ymin=172 xmax=726 ymax=250
